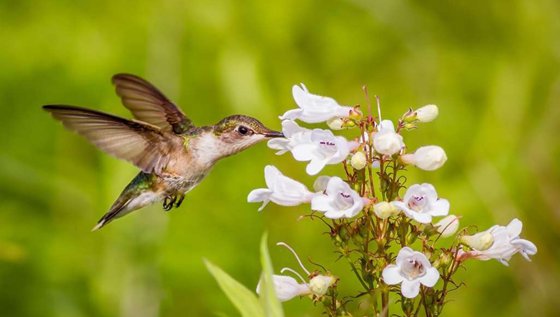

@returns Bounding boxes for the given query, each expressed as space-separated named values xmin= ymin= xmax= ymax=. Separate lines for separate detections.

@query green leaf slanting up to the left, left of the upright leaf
xmin=204 ymin=259 xmax=265 ymax=317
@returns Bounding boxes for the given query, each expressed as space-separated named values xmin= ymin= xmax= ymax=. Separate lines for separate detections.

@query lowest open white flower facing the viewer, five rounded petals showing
xmin=382 ymin=247 xmax=439 ymax=298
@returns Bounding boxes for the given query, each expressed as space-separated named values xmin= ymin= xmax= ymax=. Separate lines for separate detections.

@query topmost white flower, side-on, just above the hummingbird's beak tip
xmin=280 ymin=84 xmax=353 ymax=123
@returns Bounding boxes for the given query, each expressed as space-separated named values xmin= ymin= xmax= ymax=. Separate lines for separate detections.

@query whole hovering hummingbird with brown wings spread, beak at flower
xmin=43 ymin=74 xmax=284 ymax=231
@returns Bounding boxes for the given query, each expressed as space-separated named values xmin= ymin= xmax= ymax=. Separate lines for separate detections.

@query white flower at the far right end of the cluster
xmin=461 ymin=219 xmax=537 ymax=266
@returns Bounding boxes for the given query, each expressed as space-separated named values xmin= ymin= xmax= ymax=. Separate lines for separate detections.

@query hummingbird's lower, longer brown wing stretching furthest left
xmin=43 ymin=105 xmax=182 ymax=174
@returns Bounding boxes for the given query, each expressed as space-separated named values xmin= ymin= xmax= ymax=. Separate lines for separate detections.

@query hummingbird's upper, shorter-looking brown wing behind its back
xmin=112 ymin=74 xmax=194 ymax=134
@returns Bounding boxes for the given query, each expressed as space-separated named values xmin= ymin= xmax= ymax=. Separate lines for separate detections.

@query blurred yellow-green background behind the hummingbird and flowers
xmin=0 ymin=0 xmax=560 ymax=317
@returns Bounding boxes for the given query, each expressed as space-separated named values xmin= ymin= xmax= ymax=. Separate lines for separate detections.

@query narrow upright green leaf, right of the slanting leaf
xmin=260 ymin=233 xmax=284 ymax=317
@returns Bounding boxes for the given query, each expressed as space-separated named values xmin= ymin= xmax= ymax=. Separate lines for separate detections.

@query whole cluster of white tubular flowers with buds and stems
xmin=247 ymin=84 xmax=537 ymax=316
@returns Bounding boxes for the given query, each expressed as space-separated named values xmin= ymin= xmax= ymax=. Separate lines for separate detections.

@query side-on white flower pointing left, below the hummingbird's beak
xmin=247 ymin=165 xmax=313 ymax=211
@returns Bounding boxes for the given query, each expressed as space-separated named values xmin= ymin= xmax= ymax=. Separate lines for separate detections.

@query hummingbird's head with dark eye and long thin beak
xmin=213 ymin=115 xmax=284 ymax=156
